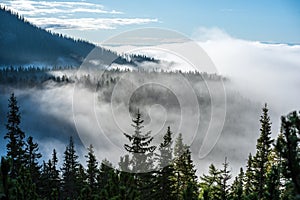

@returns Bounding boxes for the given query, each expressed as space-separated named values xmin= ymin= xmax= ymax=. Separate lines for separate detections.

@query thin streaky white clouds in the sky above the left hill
xmin=1 ymin=0 xmax=158 ymax=30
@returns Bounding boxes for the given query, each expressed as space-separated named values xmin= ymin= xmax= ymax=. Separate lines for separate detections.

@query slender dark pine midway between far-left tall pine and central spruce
xmin=62 ymin=137 xmax=79 ymax=199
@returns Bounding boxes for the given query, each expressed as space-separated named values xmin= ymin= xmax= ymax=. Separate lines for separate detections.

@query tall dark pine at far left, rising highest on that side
xmin=4 ymin=93 xmax=25 ymax=178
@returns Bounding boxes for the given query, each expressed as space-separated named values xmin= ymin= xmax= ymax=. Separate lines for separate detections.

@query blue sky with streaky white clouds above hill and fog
xmin=0 ymin=0 xmax=300 ymax=44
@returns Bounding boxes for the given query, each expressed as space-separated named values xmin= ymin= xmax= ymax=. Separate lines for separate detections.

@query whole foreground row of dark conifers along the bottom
xmin=0 ymin=94 xmax=300 ymax=200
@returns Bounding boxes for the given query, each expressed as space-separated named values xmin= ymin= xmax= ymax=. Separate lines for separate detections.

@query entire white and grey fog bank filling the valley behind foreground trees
xmin=0 ymin=29 xmax=300 ymax=175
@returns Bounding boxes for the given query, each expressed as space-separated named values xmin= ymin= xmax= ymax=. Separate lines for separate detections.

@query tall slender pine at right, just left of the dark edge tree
xmin=253 ymin=104 xmax=273 ymax=199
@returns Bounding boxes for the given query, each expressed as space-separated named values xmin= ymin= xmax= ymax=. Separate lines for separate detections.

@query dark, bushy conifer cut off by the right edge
xmin=276 ymin=111 xmax=300 ymax=197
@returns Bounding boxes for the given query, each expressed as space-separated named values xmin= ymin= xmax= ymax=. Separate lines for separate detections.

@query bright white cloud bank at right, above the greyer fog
xmin=198 ymin=29 xmax=300 ymax=116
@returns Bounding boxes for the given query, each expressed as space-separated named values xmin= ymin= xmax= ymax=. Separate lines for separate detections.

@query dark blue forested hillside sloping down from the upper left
xmin=0 ymin=7 xmax=158 ymax=67
